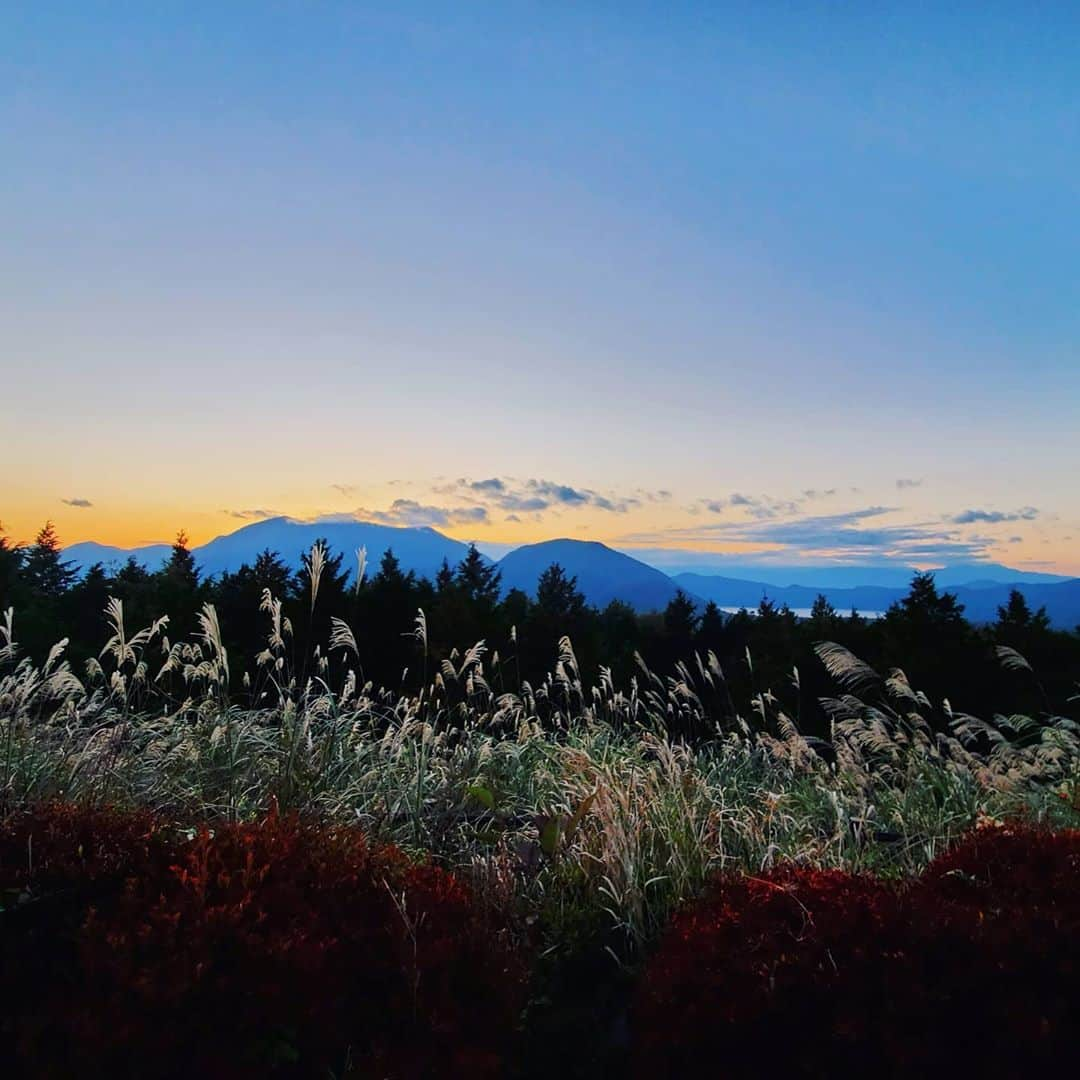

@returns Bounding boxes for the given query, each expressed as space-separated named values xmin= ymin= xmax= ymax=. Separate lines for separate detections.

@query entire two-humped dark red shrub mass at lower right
xmin=633 ymin=828 xmax=1080 ymax=1078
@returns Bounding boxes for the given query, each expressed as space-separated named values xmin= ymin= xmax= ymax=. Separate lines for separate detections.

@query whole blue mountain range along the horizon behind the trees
xmin=64 ymin=517 xmax=1080 ymax=629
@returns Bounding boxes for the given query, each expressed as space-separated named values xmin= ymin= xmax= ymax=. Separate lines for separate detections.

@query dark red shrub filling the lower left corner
xmin=0 ymin=807 xmax=521 ymax=1078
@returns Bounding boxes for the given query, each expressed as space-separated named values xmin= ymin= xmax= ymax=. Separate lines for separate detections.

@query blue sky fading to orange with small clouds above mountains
xmin=0 ymin=0 xmax=1080 ymax=575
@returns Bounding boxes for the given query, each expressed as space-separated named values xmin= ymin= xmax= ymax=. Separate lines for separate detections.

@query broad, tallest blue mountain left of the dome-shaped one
xmin=192 ymin=517 xmax=477 ymax=578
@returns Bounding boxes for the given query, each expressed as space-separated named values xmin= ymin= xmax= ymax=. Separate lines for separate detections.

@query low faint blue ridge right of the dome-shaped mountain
xmin=672 ymin=573 xmax=1080 ymax=630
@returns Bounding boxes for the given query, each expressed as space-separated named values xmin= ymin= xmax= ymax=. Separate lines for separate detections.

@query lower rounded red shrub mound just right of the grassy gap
xmin=633 ymin=868 xmax=900 ymax=1078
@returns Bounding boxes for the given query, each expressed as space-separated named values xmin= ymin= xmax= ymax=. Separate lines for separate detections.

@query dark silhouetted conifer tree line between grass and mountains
xmin=0 ymin=523 xmax=1080 ymax=733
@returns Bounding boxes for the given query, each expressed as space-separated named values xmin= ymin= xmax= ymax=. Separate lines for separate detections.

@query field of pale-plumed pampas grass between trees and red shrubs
xmin=0 ymin=594 xmax=1080 ymax=1067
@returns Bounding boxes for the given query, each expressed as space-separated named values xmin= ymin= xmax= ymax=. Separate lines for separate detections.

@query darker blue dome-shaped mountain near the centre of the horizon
xmin=498 ymin=540 xmax=678 ymax=611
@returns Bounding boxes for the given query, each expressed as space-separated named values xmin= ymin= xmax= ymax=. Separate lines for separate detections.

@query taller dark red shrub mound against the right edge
xmin=894 ymin=826 xmax=1080 ymax=1077
